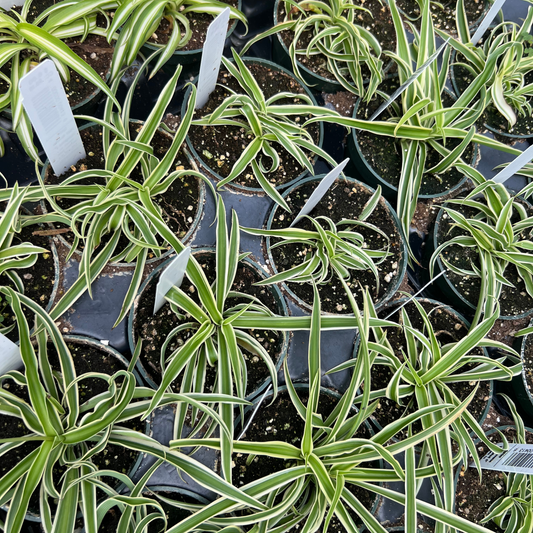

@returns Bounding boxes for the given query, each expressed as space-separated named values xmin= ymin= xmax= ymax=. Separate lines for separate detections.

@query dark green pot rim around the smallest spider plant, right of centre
xmin=265 ymin=174 xmax=407 ymax=313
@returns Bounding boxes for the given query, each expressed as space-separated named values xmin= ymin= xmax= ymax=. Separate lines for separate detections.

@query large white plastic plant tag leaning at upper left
xmin=19 ymin=59 xmax=85 ymax=176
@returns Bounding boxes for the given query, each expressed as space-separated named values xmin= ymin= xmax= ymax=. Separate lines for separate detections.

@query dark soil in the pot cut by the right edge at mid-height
xmin=437 ymin=200 xmax=533 ymax=316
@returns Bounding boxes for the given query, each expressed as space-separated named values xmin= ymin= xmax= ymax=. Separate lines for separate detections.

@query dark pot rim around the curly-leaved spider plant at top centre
xmin=272 ymin=0 xmax=394 ymax=93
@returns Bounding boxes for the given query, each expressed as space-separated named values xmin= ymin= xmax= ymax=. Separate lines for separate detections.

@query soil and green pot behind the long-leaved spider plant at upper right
xmin=347 ymin=77 xmax=480 ymax=202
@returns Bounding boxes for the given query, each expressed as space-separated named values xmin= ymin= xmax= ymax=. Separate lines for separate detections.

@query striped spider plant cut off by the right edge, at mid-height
xmin=429 ymin=181 xmax=533 ymax=323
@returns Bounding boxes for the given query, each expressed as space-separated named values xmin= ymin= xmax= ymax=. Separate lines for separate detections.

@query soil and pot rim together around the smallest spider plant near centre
xmin=258 ymin=175 xmax=407 ymax=314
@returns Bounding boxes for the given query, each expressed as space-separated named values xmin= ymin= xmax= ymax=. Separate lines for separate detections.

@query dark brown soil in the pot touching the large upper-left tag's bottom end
xmin=45 ymin=123 xmax=202 ymax=259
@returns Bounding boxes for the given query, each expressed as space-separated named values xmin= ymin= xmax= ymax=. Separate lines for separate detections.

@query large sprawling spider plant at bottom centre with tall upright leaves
xmin=168 ymin=286 xmax=487 ymax=533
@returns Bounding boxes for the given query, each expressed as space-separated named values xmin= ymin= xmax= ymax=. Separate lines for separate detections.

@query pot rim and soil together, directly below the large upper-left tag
xmin=41 ymin=120 xmax=206 ymax=268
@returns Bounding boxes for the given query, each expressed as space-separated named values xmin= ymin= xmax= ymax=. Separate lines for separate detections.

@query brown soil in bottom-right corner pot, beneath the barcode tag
xmin=455 ymin=428 xmax=533 ymax=532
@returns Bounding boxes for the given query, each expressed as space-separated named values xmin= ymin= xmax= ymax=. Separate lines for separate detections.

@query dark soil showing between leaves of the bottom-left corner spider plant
xmin=0 ymin=335 xmax=145 ymax=522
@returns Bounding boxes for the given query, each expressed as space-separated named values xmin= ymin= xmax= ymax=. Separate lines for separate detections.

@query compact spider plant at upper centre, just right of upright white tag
xmin=192 ymin=50 xmax=337 ymax=211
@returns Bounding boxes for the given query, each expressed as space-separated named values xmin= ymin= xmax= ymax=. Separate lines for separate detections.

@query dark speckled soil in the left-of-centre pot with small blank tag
xmin=133 ymin=252 xmax=283 ymax=394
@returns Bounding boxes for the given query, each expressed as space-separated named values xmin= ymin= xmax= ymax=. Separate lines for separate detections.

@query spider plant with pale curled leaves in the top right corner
xmin=442 ymin=0 xmax=533 ymax=127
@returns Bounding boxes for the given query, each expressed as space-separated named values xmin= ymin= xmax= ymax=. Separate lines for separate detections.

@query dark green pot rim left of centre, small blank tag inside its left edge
xmin=128 ymin=247 xmax=289 ymax=400
